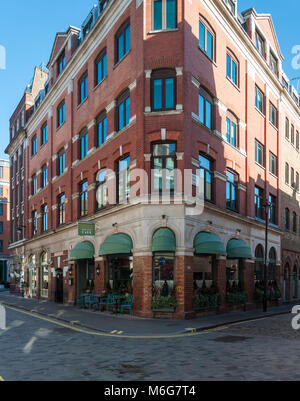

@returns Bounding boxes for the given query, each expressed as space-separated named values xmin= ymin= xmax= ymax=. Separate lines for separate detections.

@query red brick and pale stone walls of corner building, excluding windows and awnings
xmin=7 ymin=0 xmax=300 ymax=319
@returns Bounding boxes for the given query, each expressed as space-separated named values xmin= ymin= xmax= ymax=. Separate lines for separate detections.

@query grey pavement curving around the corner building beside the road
xmin=0 ymin=292 xmax=300 ymax=337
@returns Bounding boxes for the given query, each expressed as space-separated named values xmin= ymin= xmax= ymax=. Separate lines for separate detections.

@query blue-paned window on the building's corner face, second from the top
xmin=151 ymin=68 xmax=176 ymax=111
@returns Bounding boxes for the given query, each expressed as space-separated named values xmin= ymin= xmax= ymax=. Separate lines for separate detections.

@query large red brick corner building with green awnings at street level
xmin=5 ymin=0 xmax=299 ymax=319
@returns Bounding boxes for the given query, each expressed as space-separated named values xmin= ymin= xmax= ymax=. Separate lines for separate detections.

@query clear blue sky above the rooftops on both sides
xmin=0 ymin=0 xmax=300 ymax=158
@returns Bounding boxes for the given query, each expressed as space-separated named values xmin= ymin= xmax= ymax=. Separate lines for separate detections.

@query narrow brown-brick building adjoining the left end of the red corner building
xmin=5 ymin=67 xmax=48 ymax=294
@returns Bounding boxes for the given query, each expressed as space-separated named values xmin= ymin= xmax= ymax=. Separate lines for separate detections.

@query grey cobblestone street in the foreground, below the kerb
xmin=0 ymin=309 xmax=300 ymax=381
